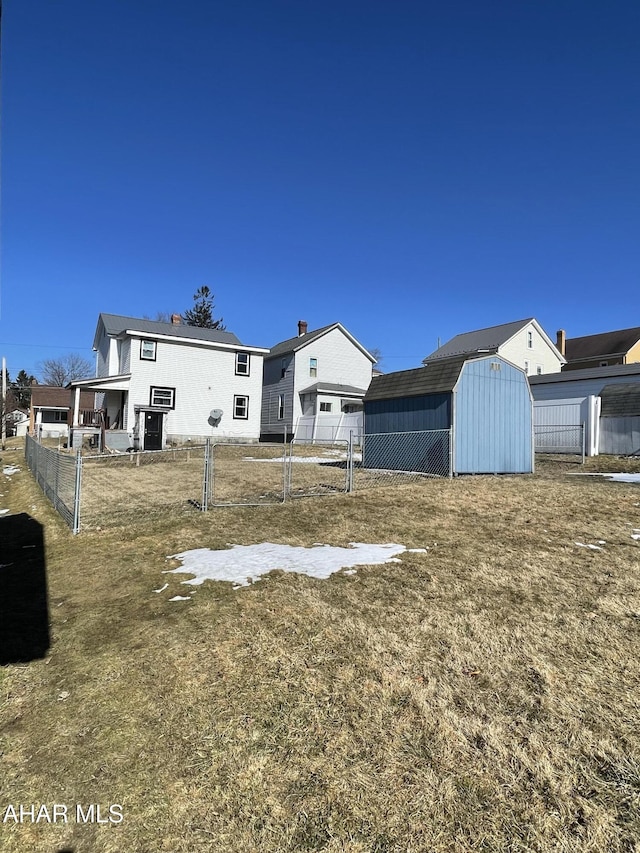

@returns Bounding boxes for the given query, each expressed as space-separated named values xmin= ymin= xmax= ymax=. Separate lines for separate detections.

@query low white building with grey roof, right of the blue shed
xmin=529 ymin=364 xmax=640 ymax=456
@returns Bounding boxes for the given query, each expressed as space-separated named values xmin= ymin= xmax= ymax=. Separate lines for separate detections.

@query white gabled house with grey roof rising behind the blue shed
xmin=422 ymin=317 xmax=565 ymax=376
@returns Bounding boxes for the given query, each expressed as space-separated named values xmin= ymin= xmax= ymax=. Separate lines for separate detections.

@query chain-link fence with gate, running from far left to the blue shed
xmin=25 ymin=430 xmax=451 ymax=533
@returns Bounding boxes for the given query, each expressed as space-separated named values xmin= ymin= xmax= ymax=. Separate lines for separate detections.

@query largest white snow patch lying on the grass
xmin=167 ymin=542 xmax=427 ymax=588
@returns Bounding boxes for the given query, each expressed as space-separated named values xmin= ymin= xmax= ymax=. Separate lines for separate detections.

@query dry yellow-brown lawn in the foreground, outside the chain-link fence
xmin=0 ymin=440 xmax=640 ymax=853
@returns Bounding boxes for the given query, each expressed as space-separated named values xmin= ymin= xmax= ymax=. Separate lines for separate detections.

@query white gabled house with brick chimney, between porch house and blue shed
xmin=260 ymin=320 xmax=375 ymax=441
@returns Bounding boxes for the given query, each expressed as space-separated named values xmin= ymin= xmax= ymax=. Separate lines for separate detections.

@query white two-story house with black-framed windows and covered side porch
xmin=70 ymin=314 xmax=268 ymax=450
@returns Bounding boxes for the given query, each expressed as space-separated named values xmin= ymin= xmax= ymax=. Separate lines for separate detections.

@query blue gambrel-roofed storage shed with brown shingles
xmin=363 ymin=355 xmax=534 ymax=474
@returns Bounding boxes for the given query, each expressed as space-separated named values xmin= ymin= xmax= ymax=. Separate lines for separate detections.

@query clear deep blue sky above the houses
xmin=0 ymin=0 xmax=640 ymax=376
